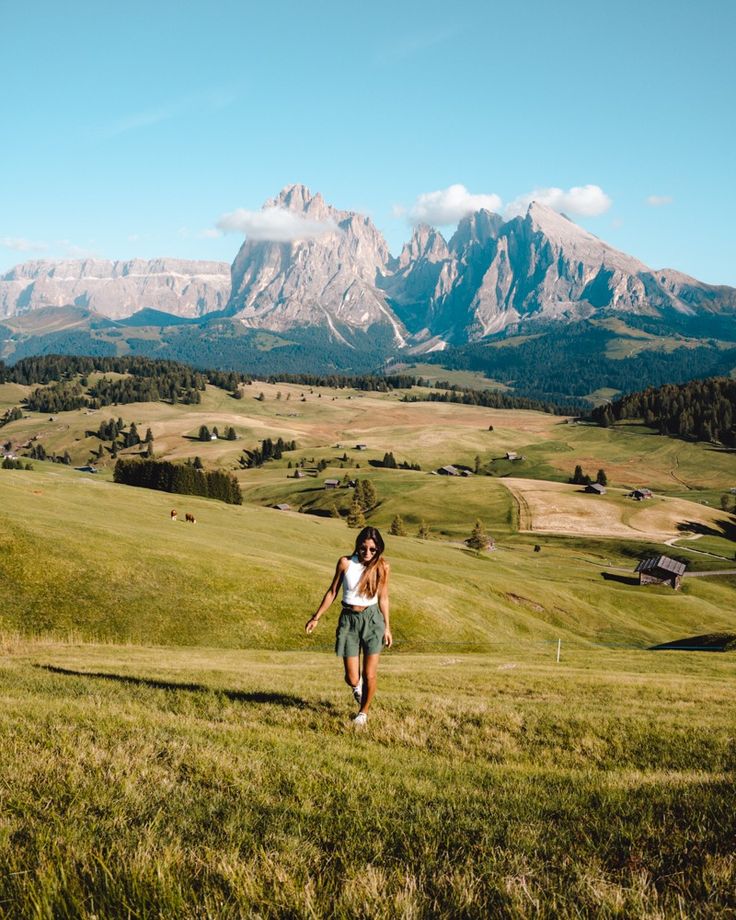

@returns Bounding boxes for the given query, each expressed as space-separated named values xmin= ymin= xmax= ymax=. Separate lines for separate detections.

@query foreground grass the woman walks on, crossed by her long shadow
xmin=0 ymin=640 xmax=736 ymax=918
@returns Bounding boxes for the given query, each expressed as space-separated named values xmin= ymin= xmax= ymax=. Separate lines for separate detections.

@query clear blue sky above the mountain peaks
xmin=0 ymin=0 xmax=736 ymax=285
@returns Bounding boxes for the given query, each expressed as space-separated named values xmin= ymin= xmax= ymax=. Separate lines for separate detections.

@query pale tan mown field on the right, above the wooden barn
xmin=500 ymin=477 xmax=729 ymax=543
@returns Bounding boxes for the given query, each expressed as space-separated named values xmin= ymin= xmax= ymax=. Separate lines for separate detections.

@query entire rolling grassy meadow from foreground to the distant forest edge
xmin=0 ymin=383 xmax=736 ymax=920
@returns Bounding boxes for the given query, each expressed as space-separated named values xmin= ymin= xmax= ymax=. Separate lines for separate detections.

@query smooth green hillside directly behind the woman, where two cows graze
xmin=0 ymin=464 xmax=736 ymax=651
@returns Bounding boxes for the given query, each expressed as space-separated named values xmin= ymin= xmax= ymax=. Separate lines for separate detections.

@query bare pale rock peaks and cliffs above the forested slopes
xmin=5 ymin=185 xmax=736 ymax=351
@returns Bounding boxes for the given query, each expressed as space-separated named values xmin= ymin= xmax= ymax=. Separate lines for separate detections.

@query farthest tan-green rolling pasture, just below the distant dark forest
xmin=0 ymin=381 xmax=736 ymax=510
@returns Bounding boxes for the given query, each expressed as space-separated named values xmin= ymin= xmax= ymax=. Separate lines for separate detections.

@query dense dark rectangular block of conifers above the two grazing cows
xmin=113 ymin=458 xmax=243 ymax=505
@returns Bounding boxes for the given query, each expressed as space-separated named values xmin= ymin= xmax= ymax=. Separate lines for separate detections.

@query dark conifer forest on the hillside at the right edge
xmin=591 ymin=377 xmax=736 ymax=447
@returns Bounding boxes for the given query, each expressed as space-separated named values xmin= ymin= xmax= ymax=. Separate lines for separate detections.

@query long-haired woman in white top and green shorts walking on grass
xmin=305 ymin=527 xmax=393 ymax=727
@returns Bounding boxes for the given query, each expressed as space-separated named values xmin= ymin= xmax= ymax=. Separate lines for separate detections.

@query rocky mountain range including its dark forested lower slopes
xmin=0 ymin=185 xmax=736 ymax=398
